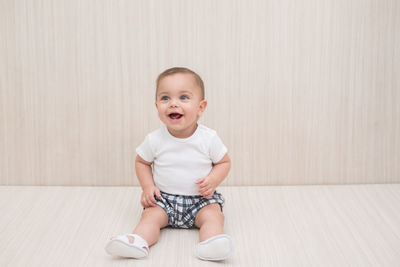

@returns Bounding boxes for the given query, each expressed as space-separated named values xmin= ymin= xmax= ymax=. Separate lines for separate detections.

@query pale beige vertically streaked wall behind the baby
xmin=0 ymin=0 xmax=400 ymax=185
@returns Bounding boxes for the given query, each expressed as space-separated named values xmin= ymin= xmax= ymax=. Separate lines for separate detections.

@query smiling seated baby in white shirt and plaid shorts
xmin=105 ymin=68 xmax=234 ymax=261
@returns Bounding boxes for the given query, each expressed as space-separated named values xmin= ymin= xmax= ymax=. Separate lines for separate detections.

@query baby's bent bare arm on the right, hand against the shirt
xmin=195 ymin=153 xmax=231 ymax=198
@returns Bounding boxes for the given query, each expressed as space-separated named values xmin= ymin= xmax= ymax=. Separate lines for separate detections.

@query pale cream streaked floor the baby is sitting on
xmin=0 ymin=184 xmax=400 ymax=267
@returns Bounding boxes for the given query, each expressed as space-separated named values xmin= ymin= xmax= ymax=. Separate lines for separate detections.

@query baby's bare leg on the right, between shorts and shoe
xmin=195 ymin=203 xmax=225 ymax=242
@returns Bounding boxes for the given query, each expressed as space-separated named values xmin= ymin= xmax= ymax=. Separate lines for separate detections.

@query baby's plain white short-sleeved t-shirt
xmin=136 ymin=124 xmax=227 ymax=195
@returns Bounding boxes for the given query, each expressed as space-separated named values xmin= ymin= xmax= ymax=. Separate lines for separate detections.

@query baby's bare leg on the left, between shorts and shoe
xmin=133 ymin=206 xmax=168 ymax=246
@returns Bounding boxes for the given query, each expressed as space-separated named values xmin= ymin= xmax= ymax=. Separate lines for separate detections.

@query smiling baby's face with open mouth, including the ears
xmin=156 ymin=73 xmax=207 ymax=138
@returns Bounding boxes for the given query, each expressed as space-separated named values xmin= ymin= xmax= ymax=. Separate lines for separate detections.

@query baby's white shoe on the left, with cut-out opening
xmin=105 ymin=234 xmax=149 ymax=259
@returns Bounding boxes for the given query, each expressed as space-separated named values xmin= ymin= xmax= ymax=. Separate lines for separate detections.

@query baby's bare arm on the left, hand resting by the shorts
xmin=135 ymin=155 xmax=161 ymax=208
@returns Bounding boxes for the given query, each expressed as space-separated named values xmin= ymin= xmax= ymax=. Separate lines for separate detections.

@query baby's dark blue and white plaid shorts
xmin=156 ymin=191 xmax=225 ymax=229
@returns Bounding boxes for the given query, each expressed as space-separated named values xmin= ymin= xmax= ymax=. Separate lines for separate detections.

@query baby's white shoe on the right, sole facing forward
xmin=196 ymin=235 xmax=234 ymax=261
